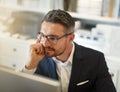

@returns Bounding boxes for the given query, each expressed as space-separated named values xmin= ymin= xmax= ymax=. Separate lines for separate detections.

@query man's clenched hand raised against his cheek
xmin=25 ymin=41 xmax=44 ymax=70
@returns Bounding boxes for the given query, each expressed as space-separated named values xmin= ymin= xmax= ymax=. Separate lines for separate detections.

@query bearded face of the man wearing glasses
xmin=40 ymin=21 xmax=69 ymax=57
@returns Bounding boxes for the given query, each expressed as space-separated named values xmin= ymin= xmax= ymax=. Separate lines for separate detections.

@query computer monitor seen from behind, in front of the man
xmin=0 ymin=66 xmax=60 ymax=92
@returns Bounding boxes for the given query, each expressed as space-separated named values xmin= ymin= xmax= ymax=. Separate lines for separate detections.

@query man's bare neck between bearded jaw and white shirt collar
xmin=56 ymin=43 xmax=73 ymax=63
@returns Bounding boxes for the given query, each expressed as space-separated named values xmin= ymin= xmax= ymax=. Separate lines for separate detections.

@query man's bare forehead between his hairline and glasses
xmin=41 ymin=21 xmax=66 ymax=35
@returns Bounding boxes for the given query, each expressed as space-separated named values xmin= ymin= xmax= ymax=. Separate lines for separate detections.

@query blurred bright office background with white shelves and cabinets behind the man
xmin=0 ymin=0 xmax=120 ymax=92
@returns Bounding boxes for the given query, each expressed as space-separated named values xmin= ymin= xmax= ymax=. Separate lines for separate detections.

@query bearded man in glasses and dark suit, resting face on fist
xmin=25 ymin=10 xmax=116 ymax=92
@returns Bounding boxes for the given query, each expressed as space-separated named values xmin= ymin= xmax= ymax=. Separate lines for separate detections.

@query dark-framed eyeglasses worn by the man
xmin=37 ymin=32 xmax=73 ymax=44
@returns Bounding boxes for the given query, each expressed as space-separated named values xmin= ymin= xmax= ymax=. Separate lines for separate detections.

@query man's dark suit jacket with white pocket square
xmin=35 ymin=44 xmax=116 ymax=92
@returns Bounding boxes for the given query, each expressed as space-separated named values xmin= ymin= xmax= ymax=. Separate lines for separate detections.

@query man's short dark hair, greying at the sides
xmin=42 ymin=9 xmax=75 ymax=33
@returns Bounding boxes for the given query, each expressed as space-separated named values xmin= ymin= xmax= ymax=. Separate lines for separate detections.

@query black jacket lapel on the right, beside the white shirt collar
xmin=68 ymin=44 xmax=84 ymax=92
